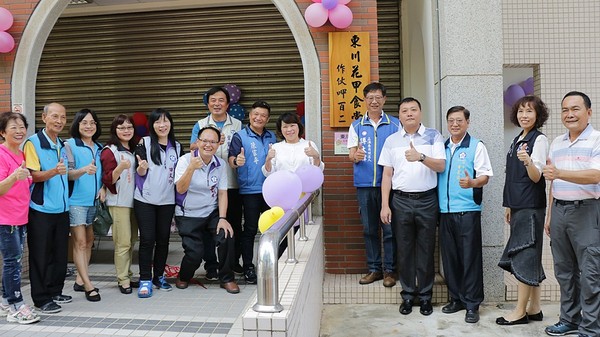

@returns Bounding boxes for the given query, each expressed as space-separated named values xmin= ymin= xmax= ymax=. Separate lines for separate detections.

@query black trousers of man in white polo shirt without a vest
xmin=390 ymin=192 xmax=439 ymax=300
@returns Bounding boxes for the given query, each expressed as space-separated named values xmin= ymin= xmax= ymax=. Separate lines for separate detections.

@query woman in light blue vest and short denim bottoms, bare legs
xmin=65 ymin=109 xmax=104 ymax=302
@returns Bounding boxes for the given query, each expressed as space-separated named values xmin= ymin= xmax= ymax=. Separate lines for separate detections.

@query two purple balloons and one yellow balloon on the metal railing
xmin=258 ymin=164 xmax=324 ymax=233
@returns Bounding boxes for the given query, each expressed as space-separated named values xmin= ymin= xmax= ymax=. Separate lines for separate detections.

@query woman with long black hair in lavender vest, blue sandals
xmin=133 ymin=108 xmax=181 ymax=298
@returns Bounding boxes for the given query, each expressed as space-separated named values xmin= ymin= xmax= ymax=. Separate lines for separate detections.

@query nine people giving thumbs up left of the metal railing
xmin=0 ymin=87 xmax=324 ymax=324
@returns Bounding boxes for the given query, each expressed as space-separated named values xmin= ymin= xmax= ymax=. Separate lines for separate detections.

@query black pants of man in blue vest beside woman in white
xmin=236 ymin=193 xmax=269 ymax=270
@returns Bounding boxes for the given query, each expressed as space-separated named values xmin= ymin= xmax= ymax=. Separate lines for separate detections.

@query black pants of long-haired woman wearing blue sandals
xmin=133 ymin=200 xmax=175 ymax=281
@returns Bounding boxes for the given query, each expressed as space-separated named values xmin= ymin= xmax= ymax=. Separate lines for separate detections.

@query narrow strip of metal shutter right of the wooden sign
xmin=377 ymin=0 xmax=401 ymax=110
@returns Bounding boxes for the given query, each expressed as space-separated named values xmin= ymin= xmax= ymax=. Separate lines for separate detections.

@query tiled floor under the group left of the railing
xmin=0 ymin=241 xmax=256 ymax=337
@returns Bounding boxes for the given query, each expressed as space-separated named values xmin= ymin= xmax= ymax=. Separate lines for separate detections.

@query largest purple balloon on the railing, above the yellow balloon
xmin=263 ymin=170 xmax=302 ymax=211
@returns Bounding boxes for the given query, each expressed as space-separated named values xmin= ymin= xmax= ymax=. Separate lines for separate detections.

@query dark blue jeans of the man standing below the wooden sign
xmin=356 ymin=187 xmax=396 ymax=272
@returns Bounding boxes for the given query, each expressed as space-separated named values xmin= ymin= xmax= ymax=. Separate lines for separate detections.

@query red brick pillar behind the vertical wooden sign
xmin=297 ymin=0 xmax=379 ymax=274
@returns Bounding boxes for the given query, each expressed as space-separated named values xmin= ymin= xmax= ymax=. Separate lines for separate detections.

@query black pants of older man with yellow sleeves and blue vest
xmin=27 ymin=208 xmax=69 ymax=307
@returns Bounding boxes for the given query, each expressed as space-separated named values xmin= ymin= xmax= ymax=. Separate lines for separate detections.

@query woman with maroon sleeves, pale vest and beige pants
xmin=100 ymin=115 xmax=137 ymax=294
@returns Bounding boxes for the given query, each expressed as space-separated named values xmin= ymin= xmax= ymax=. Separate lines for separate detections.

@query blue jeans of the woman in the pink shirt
xmin=0 ymin=225 xmax=27 ymax=304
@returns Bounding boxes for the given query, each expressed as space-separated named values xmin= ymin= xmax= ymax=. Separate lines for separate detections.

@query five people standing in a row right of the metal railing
xmin=348 ymin=83 xmax=600 ymax=337
